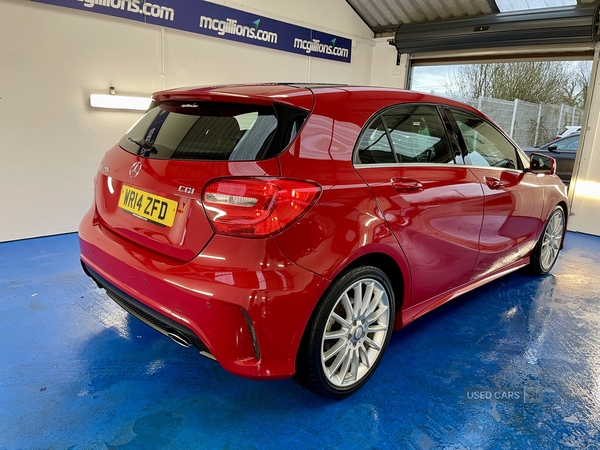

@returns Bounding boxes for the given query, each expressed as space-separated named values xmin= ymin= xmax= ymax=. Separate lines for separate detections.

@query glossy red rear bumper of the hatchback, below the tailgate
xmin=79 ymin=207 xmax=329 ymax=379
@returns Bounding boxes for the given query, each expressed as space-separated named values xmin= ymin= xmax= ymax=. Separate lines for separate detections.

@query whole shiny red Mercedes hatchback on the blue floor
xmin=79 ymin=84 xmax=568 ymax=398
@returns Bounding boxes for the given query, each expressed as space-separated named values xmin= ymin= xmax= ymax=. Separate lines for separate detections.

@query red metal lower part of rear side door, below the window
xmin=358 ymin=166 xmax=483 ymax=306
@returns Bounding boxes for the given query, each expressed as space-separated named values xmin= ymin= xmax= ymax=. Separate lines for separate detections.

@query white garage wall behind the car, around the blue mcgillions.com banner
xmin=0 ymin=0 xmax=374 ymax=242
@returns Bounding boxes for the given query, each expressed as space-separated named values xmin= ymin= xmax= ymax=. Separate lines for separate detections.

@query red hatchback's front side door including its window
xmin=446 ymin=108 xmax=544 ymax=279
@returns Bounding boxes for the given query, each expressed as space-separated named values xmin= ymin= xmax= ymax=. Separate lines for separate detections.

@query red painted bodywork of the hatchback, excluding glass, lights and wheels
xmin=80 ymin=85 xmax=568 ymax=378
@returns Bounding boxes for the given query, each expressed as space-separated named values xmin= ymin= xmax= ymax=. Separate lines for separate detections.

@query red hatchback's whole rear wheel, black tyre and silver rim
xmin=294 ymin=266 xmax=395 ymax=400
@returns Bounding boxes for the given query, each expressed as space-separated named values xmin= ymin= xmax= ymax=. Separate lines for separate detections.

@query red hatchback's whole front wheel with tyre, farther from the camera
xmin=528 ymin=206 xmax=566 ymax=275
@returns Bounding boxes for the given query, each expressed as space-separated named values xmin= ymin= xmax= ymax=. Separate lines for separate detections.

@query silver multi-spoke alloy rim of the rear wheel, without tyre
xmin=321 ymin=278 xmax=391 ymax=387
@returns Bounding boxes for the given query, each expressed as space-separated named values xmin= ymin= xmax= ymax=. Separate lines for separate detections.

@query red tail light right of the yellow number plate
xmin=202 ymin=178 xmax=321 ymax=237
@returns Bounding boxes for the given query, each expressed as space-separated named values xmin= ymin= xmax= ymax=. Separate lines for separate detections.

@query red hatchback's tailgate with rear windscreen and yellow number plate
xmin=95 ymin=99 xmax=308 ymax=260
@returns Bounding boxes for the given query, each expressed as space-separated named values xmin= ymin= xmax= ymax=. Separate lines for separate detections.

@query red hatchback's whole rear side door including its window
xmin=354 ymin=104 xmax=483 ymax=307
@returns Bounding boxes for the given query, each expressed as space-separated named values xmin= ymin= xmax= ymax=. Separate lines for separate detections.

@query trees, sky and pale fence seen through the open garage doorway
xmin=410 ymin=60 xmax=592 ymax=148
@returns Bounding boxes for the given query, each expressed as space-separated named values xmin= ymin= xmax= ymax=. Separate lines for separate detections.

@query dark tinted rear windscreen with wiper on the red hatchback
xmin=119 ymin=102 xmax=308 ymax=161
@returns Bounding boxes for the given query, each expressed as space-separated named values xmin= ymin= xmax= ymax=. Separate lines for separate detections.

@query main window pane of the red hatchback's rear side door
xmin=382 ymin=105 xmax=454 ymax=164
